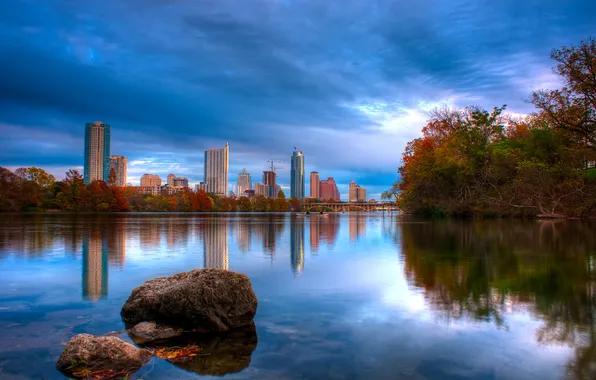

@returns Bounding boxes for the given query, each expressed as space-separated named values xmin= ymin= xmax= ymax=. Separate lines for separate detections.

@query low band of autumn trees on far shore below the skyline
xmin=0 ymin=167 xmax=302 ymax=212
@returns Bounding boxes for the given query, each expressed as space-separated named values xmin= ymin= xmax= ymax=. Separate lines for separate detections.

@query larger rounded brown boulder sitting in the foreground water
xmin=120 ymin=269 xmax=258 ymax=332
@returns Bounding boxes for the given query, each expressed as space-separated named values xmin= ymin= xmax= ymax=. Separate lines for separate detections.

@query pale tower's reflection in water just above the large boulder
xmin=202 ymin=219 xmax=228 ymax=269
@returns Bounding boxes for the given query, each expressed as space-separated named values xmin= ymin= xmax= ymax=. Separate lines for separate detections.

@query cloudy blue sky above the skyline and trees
xmin=0 ymin=0 xmax=596 ymax=199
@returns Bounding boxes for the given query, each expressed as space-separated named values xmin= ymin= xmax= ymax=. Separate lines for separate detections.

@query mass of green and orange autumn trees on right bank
xmin=392 ymin=38 xmax=596 ymax=218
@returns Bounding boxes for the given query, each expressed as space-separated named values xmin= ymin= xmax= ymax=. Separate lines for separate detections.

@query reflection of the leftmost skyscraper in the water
xmin=83 ymin=230 xmax=108 ymax=301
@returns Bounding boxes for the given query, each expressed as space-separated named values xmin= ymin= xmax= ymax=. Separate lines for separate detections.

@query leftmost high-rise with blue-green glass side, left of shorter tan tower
xmin=84 ymin=121 xmax=110 ymax=183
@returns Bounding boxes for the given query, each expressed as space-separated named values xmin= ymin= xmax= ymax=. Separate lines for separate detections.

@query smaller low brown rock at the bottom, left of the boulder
xmin=56 ymin=334 xmax=152 ymax=377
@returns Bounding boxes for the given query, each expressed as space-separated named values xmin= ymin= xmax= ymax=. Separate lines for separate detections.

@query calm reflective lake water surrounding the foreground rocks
xmin=0 ymin=214 xmax=596 ymax=380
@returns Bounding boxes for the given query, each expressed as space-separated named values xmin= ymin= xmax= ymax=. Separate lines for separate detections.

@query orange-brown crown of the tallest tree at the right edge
xmin=532 ymin=38 xmax=596 ymax=150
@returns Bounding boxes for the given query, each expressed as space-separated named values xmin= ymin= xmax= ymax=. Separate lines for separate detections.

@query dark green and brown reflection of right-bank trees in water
xmin=394 ymin=220 xmax=596 ymax=379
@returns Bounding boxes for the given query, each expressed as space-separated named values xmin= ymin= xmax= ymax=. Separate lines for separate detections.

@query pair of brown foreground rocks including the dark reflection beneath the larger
xmin=56 ymin=269 xmax=258 ymax=379
